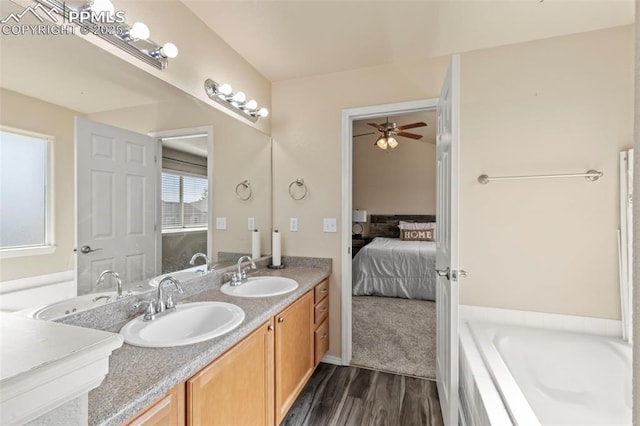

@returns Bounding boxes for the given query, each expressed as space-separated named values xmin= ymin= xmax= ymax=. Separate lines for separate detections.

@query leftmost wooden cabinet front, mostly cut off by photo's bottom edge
xmin=126 ymin=383 xmax=186 ymax=426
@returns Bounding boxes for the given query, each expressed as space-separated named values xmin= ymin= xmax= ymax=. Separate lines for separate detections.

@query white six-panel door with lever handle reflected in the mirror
xmin=75 ymin=117 xmax=159 ymax=295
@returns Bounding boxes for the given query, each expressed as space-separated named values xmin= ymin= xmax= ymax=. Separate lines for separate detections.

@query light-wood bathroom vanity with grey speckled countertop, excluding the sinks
xmin=79 ymin=261 xmax=331 ymax=425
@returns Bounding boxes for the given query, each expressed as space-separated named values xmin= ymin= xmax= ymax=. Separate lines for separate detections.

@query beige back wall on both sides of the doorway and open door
xmin=273 ymin=27 xmax=633 ymax=356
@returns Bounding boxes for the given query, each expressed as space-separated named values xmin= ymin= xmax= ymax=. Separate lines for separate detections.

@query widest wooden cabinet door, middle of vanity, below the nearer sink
xmin=187 ymin=321 xmax=274 ymax=426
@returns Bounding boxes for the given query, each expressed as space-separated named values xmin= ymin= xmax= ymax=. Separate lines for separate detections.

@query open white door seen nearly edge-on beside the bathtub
xmin=436 ymin=55 xmax=460 ymax=426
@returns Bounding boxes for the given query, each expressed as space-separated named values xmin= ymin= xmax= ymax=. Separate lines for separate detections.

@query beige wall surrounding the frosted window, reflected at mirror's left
xmin=0 ymin=89 xmax=79 ymax=281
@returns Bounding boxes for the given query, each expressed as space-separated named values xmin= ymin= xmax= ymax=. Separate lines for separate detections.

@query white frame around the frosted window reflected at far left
xmin=0 ymin=124 xmax=56 ymax=259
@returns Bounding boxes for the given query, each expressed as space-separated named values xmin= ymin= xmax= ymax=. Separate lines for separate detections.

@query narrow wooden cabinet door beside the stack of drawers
xmin=275 ymin=291 xmax=314 ymax=424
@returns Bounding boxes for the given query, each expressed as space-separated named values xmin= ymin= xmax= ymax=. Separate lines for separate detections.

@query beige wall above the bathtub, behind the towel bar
xmin=460 ymin=26 xmax=633 ymax=319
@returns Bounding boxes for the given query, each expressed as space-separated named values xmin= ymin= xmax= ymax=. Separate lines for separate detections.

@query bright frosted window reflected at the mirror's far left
xmin=0 ymin=129 xmax=53 ymax=254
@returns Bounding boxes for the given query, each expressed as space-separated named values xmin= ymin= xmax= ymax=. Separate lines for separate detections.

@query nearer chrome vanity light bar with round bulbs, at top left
xmin=35 ymin=0 xmax=178 ymax=70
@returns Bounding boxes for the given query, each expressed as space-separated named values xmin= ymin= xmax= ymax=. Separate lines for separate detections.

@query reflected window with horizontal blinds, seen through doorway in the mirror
xmin=162 ymin=172 xmax=209 ymax=230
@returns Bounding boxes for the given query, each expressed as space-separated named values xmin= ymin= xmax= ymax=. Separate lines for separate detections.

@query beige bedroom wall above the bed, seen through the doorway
xmin=352 ymin=138 xmax=436 ymax=225
